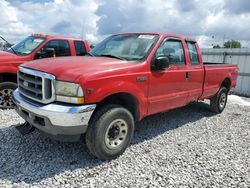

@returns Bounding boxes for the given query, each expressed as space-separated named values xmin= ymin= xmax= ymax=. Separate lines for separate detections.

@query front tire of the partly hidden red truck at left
xmin=0 ymin=82 xmax=17 ymax=109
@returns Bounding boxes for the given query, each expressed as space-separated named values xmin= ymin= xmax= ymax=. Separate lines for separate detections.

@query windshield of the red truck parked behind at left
xmin=8 ymin=36 xmax=45 ymax=55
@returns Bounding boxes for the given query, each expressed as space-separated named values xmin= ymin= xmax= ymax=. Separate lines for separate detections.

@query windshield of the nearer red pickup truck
xmin=90 ymin=34 xmax=158 ymax=60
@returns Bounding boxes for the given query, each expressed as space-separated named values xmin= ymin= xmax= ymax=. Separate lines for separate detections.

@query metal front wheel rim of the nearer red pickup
xmin=105 ymin=119 xmax=128 ymax=149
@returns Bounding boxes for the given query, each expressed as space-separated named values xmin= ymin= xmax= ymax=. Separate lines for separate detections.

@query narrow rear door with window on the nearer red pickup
xmin=186 ymin=41 xmax=205 ymax=103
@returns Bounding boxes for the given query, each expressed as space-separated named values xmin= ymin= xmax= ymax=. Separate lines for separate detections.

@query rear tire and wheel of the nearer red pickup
xmin=210 ymin=86 xmax=228 ymax=113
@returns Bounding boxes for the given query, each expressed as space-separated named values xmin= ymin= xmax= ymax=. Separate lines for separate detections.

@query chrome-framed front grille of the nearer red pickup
xmin=18 ymin=67 xmax=55 ymax=104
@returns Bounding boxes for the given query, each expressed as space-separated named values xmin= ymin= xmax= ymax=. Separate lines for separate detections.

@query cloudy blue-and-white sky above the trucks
xmin=0 ymin=0 xmax=250 ymax=47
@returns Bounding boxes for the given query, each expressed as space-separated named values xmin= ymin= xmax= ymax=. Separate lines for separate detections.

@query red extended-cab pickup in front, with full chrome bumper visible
xmin=13 ymin=33 xmax=238 ymax=159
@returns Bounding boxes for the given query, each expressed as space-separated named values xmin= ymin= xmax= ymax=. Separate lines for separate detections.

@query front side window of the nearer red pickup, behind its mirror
xmin=155 ymin=39 xmax=185 ymax=66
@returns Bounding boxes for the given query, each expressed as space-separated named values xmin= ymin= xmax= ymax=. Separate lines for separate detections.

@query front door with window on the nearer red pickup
xmin=148 ymin=38 xmax=188 ymax=114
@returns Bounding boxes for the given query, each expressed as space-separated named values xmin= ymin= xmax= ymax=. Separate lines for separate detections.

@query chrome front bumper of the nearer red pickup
xmin=13 ymin=89 xmax=96 ymax=135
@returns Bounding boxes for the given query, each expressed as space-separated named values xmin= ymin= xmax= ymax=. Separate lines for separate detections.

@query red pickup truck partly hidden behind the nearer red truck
xmin=0 ymin=34 xmax=90 ymax=108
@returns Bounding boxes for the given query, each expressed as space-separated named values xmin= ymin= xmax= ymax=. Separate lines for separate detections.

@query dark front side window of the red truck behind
xmin=44 ymin=40 xmax=70 ymax=57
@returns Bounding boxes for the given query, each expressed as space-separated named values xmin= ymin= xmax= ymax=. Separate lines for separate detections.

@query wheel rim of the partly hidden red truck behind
xmin=0 ymin=89 xmax=14 ymax=108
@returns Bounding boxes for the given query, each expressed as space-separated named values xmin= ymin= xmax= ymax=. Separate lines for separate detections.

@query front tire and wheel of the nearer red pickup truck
xmin=86 ymin=105 xmax=134 ymax=160
